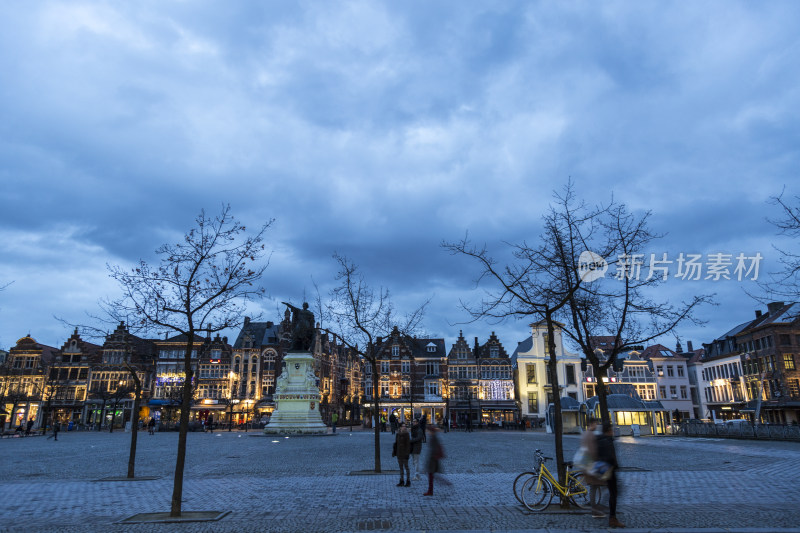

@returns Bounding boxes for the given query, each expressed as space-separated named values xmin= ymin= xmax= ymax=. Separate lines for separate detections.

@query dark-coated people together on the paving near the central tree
xmin=392 ymin=413 xmax=446 ymax=496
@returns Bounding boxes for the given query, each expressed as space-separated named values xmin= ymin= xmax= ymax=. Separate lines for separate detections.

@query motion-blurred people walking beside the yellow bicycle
xmin=579 ymin=418 xmax=625 ymax=527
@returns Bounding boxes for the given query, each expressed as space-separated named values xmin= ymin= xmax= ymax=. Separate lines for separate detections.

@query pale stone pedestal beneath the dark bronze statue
xmin=264 ymin=352 xmax=328 ymax=435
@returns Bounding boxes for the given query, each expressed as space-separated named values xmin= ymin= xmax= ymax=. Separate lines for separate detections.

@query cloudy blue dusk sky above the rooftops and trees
xmin=0 ymin=0 xmax=800 ymax=352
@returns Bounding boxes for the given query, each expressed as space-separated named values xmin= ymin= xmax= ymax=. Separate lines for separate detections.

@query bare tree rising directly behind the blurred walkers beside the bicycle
xmin=554 ymin=205 xmax=712 ymax=430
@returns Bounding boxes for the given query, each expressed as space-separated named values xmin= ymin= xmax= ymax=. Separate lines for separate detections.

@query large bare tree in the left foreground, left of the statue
xmin=103 ymin=206 xmax=272 ymax=517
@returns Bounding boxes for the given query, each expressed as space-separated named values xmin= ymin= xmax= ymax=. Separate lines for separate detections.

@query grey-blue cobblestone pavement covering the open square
xmin=0 ymin=431 xmax=800 ymax=532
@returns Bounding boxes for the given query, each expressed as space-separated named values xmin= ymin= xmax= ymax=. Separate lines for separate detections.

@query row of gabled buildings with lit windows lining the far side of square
xmin=0 ymin=303 xmax=800 ymax=434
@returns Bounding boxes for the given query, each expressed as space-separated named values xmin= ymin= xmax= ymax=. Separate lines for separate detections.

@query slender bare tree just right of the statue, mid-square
xmin=320 ymin=254 xmax=429 ymax=472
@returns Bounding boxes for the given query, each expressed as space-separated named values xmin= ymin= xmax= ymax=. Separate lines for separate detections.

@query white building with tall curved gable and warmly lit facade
xmin=511 ymin=321 xmax=585 ymax=421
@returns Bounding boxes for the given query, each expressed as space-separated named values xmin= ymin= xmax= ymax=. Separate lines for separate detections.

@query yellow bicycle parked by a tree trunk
xmin=521 ymin=450 xmax=599 ymax=511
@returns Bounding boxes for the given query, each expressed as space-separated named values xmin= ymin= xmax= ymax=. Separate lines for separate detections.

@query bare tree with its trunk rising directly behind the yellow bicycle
xmin=442 ymin=183 xmax=607 ymax=490
